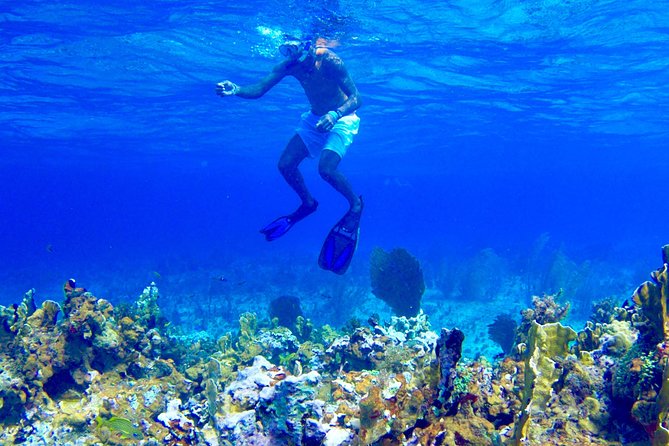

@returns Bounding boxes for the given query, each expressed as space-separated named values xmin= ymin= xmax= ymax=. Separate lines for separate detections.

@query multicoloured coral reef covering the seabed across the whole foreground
xmin=0 ymin=248 xmax=669 ymax=446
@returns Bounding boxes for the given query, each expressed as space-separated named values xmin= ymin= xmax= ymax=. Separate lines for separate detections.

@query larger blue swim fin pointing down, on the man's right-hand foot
xmin=318 ymin=197 xmax=362 ymax=275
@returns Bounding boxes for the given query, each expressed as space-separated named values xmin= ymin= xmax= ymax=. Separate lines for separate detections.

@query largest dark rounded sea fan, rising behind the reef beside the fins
xmin=369 ymin=248 xmax=425 ymax=317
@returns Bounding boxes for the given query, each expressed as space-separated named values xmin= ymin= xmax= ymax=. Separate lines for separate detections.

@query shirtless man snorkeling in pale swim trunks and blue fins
xmin=216 ymin=38 xmax=362 ymax=274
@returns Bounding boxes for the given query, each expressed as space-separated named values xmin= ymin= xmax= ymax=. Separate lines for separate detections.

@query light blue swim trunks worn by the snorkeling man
xmin=295 ymin=111 xmax=360 ymax=158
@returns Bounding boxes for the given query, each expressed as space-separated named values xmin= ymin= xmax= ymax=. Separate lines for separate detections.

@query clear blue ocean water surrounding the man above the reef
xmin=0 ymin=0 xmax=669 ymax=334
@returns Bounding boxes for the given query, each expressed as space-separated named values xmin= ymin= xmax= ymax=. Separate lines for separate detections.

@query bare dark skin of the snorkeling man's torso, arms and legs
xmin=216 ymin=39 xmax=362 ymax=225
